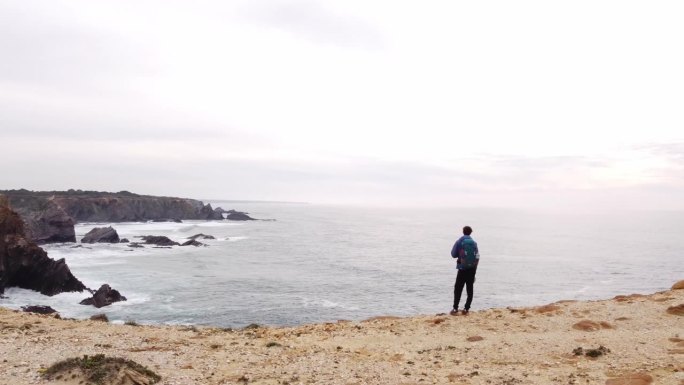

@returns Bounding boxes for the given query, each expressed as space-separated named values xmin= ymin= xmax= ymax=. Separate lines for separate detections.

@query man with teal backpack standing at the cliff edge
xmin=450 ymin=226 xmax=480 ymax=315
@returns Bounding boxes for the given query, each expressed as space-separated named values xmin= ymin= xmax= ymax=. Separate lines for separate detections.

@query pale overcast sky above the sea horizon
xmin=0 ymin=0 xmax=684 ymax=210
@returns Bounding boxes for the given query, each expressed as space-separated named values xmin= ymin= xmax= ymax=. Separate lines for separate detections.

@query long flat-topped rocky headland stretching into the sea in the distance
xmin=0 ymin=190 xmax=223 ymax=243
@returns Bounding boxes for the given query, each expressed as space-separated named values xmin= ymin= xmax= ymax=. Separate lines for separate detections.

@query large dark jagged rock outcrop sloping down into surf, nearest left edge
xmin=0 ymin=195 xmax=86 ymax=296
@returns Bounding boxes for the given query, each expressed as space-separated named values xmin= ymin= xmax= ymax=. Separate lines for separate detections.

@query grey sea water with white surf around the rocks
xmin=0 ymin=202 xmax=684 ymax=327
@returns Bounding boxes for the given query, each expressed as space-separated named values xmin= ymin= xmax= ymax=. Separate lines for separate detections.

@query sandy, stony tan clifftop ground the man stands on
xmin=0 ymin=285 xmax=684 ymax=385
